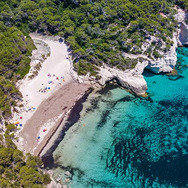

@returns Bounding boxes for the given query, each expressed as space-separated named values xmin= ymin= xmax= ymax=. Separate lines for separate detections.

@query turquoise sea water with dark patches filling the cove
xmin=50 ymin=48 xmax=188 ymax=188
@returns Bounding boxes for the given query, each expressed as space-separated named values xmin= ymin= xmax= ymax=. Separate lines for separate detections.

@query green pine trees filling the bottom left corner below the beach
xmin=0 ymin=124 xmax=51 ymax=188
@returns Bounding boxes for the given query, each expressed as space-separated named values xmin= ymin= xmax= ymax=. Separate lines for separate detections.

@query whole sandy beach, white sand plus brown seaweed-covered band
xmin=10 ymin=33 xmax=90 ymax=155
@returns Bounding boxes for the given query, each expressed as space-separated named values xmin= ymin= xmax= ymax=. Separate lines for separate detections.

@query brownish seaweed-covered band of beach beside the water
xmin=18 ymin=82 xmax=91 ymax=155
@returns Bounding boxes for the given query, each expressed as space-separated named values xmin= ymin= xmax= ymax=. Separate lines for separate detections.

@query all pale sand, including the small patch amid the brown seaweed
xmin=9 ymin=33 xmax=74 ymax=150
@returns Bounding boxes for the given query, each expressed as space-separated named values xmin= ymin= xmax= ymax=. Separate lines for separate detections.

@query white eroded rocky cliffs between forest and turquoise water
xmin=71 ymin=9 xmax=188 ymax=95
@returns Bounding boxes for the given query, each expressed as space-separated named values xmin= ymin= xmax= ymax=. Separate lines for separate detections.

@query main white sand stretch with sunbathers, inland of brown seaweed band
xmin=11 ymin=34 xmax=73 ymax=128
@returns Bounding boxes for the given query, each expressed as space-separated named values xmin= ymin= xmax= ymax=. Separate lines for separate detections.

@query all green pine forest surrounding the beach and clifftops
xmin=0 ymin=0 xmax=188 ymax=188
